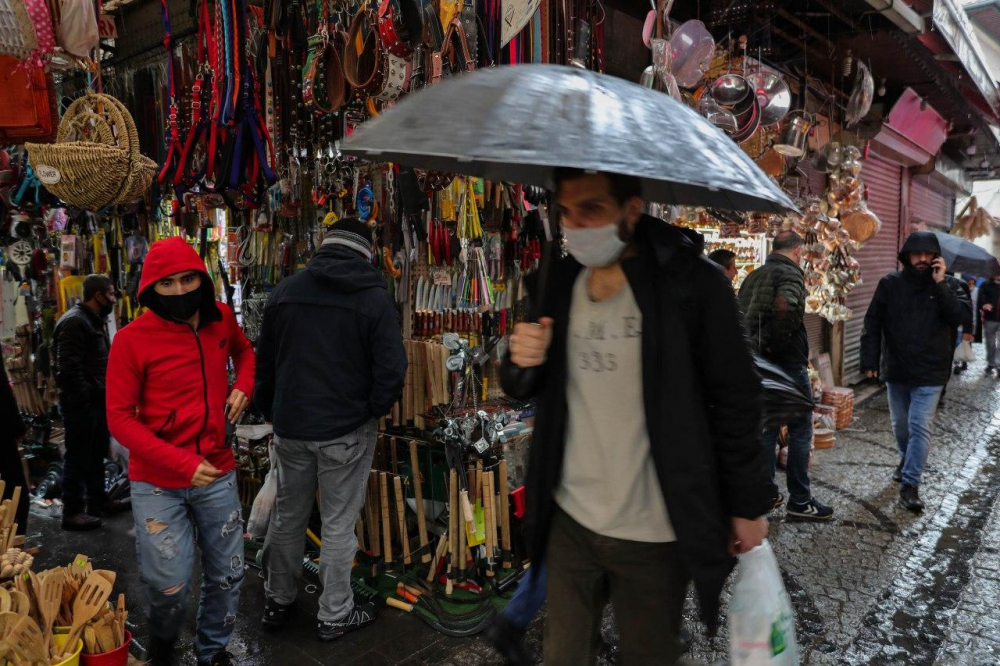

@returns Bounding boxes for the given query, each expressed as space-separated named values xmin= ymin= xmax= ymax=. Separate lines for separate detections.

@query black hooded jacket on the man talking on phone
xmin=861 ymin=231 xmax=972 ymax=386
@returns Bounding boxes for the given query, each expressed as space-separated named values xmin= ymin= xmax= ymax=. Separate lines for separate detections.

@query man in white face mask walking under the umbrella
xmin=502 ymin=170 xmax=775 ymax=666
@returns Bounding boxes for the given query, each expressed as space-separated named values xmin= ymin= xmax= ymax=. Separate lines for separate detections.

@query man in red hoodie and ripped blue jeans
xmin=107 ymin=238 xmax=254 ymax=666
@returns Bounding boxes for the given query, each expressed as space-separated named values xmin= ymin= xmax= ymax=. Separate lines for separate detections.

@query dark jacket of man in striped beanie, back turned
xmin=254 ymin=245 xmax=407 ymax=441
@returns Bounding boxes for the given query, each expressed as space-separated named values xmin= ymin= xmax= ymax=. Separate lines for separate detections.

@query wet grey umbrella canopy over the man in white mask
xmin=341 ymin=65 xmax=795 ymax=213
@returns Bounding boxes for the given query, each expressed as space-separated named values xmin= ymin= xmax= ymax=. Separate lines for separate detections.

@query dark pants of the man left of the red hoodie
xmin=63 ymin=405 xmax=111 ymax=516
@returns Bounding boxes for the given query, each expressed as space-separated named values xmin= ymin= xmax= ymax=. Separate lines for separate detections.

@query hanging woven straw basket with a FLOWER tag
xmin=25 ymin=93 xmax=156 ymax=211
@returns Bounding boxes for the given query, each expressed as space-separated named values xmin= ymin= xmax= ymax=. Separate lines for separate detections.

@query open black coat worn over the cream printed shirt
xmin=501 ymin=216 xmax=777 ymax=627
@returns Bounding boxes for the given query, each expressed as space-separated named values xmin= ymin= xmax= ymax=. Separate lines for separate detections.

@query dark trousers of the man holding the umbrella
xmin=543 ymin=509 xmax=690 ymax=666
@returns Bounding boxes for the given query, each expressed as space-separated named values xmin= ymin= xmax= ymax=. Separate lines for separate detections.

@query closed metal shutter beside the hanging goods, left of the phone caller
xmin=843 ymin=155 xmax=902 ymax=385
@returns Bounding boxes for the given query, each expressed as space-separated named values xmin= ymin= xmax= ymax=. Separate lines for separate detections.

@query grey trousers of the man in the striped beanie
xmin=264 ymin=419 xmax=378 ymax=622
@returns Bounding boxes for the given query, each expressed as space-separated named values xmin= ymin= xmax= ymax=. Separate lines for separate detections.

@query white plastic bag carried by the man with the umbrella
xmin=729 ymin=540 xmax=799 ymax=666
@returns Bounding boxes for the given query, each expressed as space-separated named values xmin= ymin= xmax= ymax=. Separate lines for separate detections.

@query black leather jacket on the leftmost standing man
xmin=52 ymin=303 xmax=111 ymax=409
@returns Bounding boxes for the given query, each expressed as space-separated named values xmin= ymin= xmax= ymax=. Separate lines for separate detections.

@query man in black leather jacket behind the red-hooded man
xmin=53 ymin=275 xmax=120 ymax=530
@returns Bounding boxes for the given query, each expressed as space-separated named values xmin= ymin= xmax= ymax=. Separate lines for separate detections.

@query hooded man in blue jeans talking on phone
xmin=861 ymin=231 xmax=972 ymax=511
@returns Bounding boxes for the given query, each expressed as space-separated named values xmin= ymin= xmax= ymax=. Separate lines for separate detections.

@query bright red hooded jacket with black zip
xmin=107 ymin=238 xmax=255 ymax=488
